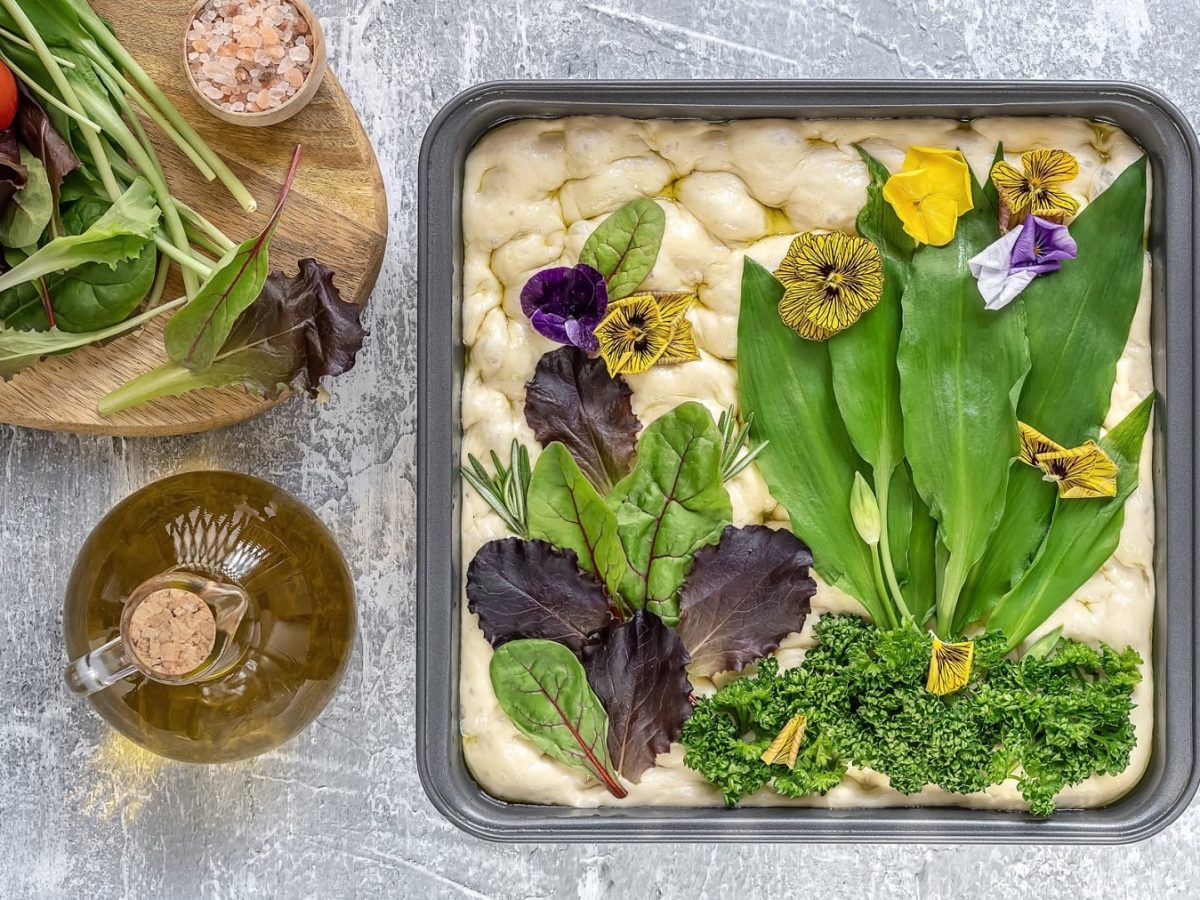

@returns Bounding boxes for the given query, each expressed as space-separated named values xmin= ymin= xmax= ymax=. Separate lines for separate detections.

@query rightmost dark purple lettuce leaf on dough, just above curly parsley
xmin=679 ymin=526 xmax=816 ymax=676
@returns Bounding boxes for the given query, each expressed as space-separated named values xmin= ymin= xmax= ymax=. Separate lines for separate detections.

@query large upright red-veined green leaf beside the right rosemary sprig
xmin=608 ymin=403 xmax=733 ymax=625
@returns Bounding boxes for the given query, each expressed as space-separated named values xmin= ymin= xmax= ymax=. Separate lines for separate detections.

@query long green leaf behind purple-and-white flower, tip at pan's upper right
xmin=956 ymin=157 xmax=1147 ymax=628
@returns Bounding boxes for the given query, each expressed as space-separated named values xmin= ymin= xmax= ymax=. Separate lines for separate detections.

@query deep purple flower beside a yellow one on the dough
xmin=521 ymin=264 xmax=608 ymax=353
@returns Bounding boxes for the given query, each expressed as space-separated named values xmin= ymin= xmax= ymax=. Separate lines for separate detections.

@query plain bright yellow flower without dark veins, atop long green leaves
xmin=883 ymin=146 xmax=974 ymax=247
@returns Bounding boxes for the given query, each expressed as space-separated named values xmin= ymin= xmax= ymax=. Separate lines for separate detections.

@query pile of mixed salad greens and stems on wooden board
xmin=0 ymin=0 xmax=365 ymax=415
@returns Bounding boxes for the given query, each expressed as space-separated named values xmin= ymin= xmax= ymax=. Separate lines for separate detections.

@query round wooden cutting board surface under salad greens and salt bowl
xmin=0 ymin=0 xmax=388 ymax=437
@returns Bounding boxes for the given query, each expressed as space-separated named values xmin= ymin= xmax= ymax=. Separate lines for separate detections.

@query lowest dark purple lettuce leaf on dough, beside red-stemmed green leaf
xmin=583 ymin=611 xmax=691 ymax=782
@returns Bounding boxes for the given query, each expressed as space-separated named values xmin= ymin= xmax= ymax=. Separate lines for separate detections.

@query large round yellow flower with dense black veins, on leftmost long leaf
xmin=775 ymin=232 xmax=883 ymax=341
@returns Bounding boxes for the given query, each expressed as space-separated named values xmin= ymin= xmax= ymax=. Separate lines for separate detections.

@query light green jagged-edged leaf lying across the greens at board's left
xmin=0 ymin=172 xmax=161 ymax=292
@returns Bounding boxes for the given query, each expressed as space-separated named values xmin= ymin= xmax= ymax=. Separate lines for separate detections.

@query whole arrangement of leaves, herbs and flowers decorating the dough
xmin=463 ymin=142 xmax=1153 ymax=815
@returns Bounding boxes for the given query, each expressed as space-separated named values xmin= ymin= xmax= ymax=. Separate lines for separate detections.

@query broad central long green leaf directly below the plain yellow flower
xmin=896 ymin=165 xmax=1030 ymax=637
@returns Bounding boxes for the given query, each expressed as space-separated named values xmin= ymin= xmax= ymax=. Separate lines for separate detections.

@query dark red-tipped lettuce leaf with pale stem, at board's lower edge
xmin=98 ymin=259 xmax=367 ymax=415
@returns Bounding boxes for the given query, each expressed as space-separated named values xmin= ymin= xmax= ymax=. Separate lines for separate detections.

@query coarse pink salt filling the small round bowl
xmin=187 ymin=0 xmax=313 ymax=113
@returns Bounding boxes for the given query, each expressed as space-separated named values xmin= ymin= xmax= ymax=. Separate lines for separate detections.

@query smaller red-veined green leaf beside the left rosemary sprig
xmin=527 ymin=442 xmax=628 ymax=607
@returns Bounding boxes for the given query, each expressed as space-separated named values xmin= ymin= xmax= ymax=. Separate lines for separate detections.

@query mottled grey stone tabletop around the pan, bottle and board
xmin=0 ymin=0 xmax=1200 ymax=899
